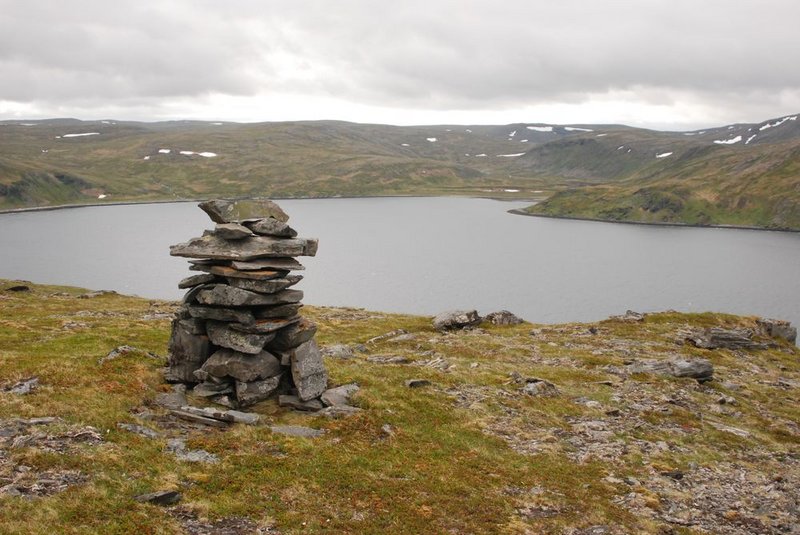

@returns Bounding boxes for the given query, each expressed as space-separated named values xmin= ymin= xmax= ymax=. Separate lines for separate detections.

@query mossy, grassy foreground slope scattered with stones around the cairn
xmin=0 ymin=281 xmax=800 ymax=534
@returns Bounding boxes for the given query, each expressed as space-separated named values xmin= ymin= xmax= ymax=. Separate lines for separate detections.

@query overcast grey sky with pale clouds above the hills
xmin=0 ymin=0 xmax=800 ymax=130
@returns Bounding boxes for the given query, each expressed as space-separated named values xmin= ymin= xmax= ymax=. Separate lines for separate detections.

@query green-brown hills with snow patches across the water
xmin=0 ymin=115 xmax=800 ymax=229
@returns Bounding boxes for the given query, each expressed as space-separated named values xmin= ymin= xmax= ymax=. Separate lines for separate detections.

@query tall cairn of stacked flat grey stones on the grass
xmin=166 ymin=200 xmax=328 ymax=408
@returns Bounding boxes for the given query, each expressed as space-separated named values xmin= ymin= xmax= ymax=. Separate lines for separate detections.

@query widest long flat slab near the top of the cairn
xmin=169 ymin=236 xmax=317 ymax=262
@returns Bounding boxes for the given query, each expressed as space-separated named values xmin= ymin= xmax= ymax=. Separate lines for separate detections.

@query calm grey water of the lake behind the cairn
xmin=0 ymin=198 xmax=800 ymax=325
